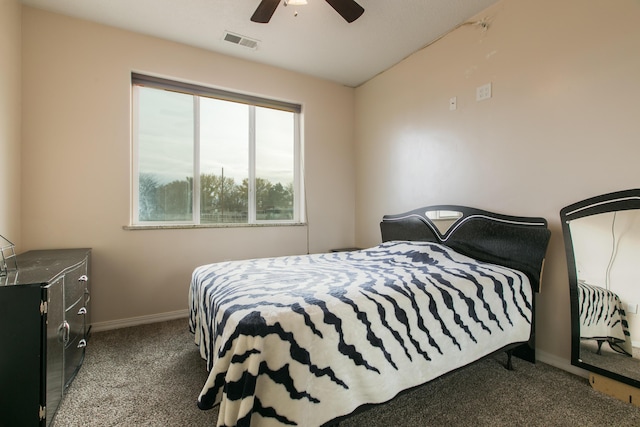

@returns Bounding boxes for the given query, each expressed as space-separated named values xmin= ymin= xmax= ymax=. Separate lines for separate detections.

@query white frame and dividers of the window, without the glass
xmin=130 ymin=73 xmax=305 ymax=228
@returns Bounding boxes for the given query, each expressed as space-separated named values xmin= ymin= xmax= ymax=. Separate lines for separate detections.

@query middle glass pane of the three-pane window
xmin=200 ymin=98 xmax=249 ymax=224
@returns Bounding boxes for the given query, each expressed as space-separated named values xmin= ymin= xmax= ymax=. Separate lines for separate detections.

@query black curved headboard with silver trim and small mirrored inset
xmin=380 ymin=205 xmax=551 ymax=292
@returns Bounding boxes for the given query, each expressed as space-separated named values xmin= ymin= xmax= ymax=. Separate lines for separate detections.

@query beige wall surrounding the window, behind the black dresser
xmin=22 ymin=7 xmax=355 ymax=323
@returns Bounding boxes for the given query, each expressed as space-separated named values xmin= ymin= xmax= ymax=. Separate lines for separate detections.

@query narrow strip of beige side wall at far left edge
xmin=0 ymin=0 xmax=22 ymax=247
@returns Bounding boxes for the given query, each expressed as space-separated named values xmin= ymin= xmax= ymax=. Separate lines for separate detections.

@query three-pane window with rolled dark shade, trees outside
xmin=132 ymin=74 xmax=302 ymax=225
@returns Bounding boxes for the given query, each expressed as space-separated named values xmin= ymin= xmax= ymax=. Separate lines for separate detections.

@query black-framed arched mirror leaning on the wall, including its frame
xmin=560 ymin=189 xmax=640 ymax=387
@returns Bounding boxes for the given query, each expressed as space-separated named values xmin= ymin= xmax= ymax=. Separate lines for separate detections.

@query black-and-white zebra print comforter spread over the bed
xmin=189 ymin=241 xmax=532 ymax=426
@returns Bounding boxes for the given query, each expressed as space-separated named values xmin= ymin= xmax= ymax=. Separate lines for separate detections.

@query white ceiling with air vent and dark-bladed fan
xmin=22 ymin=0 xmax=497 ymax=87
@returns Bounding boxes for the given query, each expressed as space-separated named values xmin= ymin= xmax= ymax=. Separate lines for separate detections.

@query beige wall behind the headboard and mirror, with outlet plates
xmin=356 ymin=0 xmax=640 ymax=368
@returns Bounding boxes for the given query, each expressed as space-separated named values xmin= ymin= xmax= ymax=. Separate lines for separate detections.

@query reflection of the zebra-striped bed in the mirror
xmin=578 ymin=280 xmax=633 ymax=356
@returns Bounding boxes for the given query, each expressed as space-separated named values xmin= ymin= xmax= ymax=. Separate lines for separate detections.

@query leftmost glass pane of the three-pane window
xmin=137 ymin=87 xmax=194 ymax=222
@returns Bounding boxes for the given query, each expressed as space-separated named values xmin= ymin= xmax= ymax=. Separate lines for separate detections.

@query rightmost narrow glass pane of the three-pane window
xmin=256 ymin=107 xmax=295 ymax=221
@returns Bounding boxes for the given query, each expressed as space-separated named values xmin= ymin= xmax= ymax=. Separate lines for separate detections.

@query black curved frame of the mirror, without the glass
xmin=560 ymin=189 xmax=640 ymax=388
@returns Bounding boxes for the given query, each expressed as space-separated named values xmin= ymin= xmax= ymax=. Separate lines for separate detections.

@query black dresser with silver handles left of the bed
xmin=0 ymin=249 xmax=91 ymax=427
